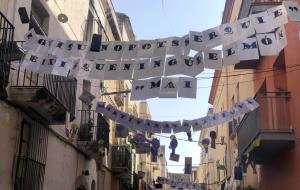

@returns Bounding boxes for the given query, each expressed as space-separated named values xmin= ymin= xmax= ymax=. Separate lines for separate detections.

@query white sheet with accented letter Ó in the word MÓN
xmin=256 ymin=33 xmax=278 ymax=56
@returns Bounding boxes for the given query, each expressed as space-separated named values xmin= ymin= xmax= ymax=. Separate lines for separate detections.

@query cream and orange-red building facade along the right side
xmin=199 ymin=0 xmax=300 ymax=189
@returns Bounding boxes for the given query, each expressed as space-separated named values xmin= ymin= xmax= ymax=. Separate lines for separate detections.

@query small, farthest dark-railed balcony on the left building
xmin=111 ymin=145 xmax=132 ymax=175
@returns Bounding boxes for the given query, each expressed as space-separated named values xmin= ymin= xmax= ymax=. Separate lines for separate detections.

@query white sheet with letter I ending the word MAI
xmin=178 ymin=77 xmax=197 ymax=98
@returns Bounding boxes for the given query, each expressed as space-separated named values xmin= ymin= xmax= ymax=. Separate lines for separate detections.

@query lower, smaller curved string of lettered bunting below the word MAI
xmin=96 ymin=98 xmax=259 ymax=134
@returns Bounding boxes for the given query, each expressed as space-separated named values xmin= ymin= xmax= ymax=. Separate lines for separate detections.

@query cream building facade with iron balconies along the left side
xmin=0 ymin=0 xmax=145 ymax=190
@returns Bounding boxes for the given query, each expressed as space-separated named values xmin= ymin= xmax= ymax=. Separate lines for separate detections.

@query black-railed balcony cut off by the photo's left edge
xmin=0 ymin=12 xmax=15 ymax=100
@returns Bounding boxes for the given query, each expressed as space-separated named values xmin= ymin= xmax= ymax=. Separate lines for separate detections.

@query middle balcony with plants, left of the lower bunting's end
xmin=77 ymin=110 xmax=109 ymax=163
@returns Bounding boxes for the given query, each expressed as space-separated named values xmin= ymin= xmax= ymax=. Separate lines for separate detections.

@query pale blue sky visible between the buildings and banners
xmin=113 ymin=0 xmax=225 ymax=173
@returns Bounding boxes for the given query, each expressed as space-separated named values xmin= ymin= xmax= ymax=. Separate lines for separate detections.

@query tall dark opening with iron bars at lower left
xmin=14 ymin=119 xmax=48 ymax=190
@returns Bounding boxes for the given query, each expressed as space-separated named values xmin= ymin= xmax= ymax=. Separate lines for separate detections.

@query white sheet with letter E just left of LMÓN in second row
xmin=204 ymin=49 xmax=223 ymax=70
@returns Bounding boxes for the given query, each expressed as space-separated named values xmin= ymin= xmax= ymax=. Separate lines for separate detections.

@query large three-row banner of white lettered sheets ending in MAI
xmin=21 ymin=1 xmax=300 ymax=100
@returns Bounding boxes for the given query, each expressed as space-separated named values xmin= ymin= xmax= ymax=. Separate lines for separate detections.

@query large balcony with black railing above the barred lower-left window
xmin=8 ymin=67 xmax=77 ymax=125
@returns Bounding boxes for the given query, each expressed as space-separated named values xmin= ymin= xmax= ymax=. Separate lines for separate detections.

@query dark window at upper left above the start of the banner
xmin=29 ymin=0 xmax=49 ymax=36
